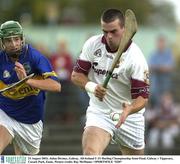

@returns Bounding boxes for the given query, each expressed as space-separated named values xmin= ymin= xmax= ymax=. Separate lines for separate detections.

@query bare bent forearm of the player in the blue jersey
xmin=26 ymin=78 xmax=61 ymax=92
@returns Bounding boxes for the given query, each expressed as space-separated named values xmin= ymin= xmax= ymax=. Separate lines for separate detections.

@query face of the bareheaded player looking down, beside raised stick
xmin=101 ymin=19 xmax=124 ymax=51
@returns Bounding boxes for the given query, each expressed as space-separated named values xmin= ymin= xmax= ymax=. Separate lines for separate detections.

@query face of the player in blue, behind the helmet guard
xmin=3 ymin=36 xmax=22 ymax=54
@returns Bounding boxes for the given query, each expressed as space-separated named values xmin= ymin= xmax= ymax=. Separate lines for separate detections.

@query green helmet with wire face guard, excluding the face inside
xmin=0 ymin=21 xmax=25 ymax=57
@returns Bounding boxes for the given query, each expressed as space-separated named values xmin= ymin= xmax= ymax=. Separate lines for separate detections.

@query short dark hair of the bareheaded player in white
xmin=101 ymin=9 xmax=124 ymax=26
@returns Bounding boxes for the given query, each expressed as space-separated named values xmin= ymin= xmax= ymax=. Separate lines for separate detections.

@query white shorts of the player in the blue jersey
xmin=0 ymin=109 xmax=43 ymax=155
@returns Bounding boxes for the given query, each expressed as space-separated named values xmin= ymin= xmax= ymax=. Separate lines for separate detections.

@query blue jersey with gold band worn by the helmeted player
xmin=0 ymin=45 xmax=58 ymax=124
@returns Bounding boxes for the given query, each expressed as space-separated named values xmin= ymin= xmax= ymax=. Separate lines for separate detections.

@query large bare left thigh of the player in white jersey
xmin=82 ymin=126 xmax=111 ymax=155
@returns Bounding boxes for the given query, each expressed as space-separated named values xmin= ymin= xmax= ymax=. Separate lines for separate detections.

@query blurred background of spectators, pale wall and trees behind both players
xmin=0 ymin=0 xmax=180 ymax=155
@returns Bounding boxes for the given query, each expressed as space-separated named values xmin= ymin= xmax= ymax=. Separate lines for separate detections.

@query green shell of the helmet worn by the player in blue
xmin=0 ymin=21 xmax=23 ymax=39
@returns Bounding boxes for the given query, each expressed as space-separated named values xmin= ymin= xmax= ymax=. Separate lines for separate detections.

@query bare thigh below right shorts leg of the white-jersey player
xmin=121 ymin=146 xmax=144 ymax=155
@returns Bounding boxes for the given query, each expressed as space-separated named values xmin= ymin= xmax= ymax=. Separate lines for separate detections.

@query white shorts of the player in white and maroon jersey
xmin=85 ymin=107 xmax=145 ymax=150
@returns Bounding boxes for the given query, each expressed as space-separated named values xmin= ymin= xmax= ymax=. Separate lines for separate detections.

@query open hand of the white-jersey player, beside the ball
xmin=115 ymin=103 xmax=132 ymax=128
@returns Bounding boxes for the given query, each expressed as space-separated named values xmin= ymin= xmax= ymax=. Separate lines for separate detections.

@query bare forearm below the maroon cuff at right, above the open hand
xmin=130 ymin=96 xmax=148 ymax=114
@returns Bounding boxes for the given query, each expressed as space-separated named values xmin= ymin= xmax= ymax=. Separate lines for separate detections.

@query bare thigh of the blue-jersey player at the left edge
xmin=0 ymin=125 xmax=13 ymax=154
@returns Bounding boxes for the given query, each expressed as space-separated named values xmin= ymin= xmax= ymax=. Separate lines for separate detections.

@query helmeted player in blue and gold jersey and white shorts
xmin=0 ymin=21 xmax=61 ymax=155
